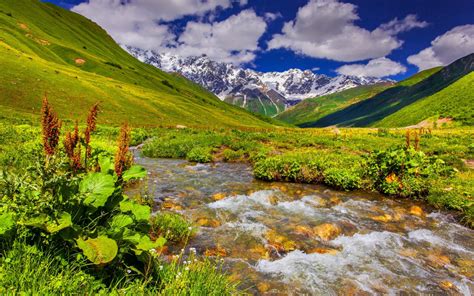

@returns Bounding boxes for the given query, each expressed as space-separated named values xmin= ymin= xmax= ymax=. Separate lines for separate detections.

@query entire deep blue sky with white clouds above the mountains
xmin=45 ymin=0 xmax=474 ymax=80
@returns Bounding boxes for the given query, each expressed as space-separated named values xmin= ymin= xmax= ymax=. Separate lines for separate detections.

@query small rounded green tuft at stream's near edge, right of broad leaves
xmin=151 ymin=212 xmax=195 ymax=242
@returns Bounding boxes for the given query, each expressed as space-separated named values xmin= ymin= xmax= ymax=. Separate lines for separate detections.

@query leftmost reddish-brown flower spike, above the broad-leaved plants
xmin=41 ymin=97 xmax=61 ymax=156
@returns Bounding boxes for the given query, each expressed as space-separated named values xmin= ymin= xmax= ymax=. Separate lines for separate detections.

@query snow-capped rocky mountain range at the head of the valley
xmin=124 ymin=46 xmax=385 ymax=116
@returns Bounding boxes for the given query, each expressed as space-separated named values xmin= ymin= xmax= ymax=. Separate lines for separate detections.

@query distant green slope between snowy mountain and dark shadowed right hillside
xmin=276 ymin=84 xmax=391 ymax=125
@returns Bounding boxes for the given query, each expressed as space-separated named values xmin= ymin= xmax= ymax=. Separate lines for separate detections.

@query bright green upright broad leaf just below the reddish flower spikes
xmin=79 ymin=173 xmax=116 ymax=208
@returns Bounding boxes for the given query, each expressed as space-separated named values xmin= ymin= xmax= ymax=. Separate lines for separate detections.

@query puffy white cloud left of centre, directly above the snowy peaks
xmin=173 ymin=9 xmax=267 ymax=64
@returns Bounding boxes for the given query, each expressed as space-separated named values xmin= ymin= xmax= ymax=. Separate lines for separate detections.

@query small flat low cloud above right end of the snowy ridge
xmin=336 ymin=58 xmax=407 ymax=77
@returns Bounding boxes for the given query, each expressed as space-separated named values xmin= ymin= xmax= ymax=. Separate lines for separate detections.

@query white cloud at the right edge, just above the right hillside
xmin=407 ymin=25 xmax=474 ymax=70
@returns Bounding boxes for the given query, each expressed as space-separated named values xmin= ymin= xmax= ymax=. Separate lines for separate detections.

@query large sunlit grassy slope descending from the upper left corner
xmin=0 ymin=0 xmax=270 ymax=126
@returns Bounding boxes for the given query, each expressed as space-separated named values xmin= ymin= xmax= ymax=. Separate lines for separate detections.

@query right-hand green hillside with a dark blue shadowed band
xmin=302 ymin=54 xmax=474 ymax=127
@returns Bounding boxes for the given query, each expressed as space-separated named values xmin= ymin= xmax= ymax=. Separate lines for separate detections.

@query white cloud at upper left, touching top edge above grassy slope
xmin=71 ymin=0 xmax=232 ymax=49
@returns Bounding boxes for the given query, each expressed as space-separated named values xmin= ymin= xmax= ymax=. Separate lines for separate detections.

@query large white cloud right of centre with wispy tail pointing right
xmin=268 ymin=0 xmax=427 ymax=62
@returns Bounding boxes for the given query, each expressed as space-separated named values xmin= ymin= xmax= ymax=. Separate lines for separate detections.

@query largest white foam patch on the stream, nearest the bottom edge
xmin=256 ymin=231 xmax=470 ymax=295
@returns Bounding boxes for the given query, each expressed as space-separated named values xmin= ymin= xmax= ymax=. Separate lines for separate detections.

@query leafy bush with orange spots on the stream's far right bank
xmin=366 ymin=148 xmax=451 ymax=197
